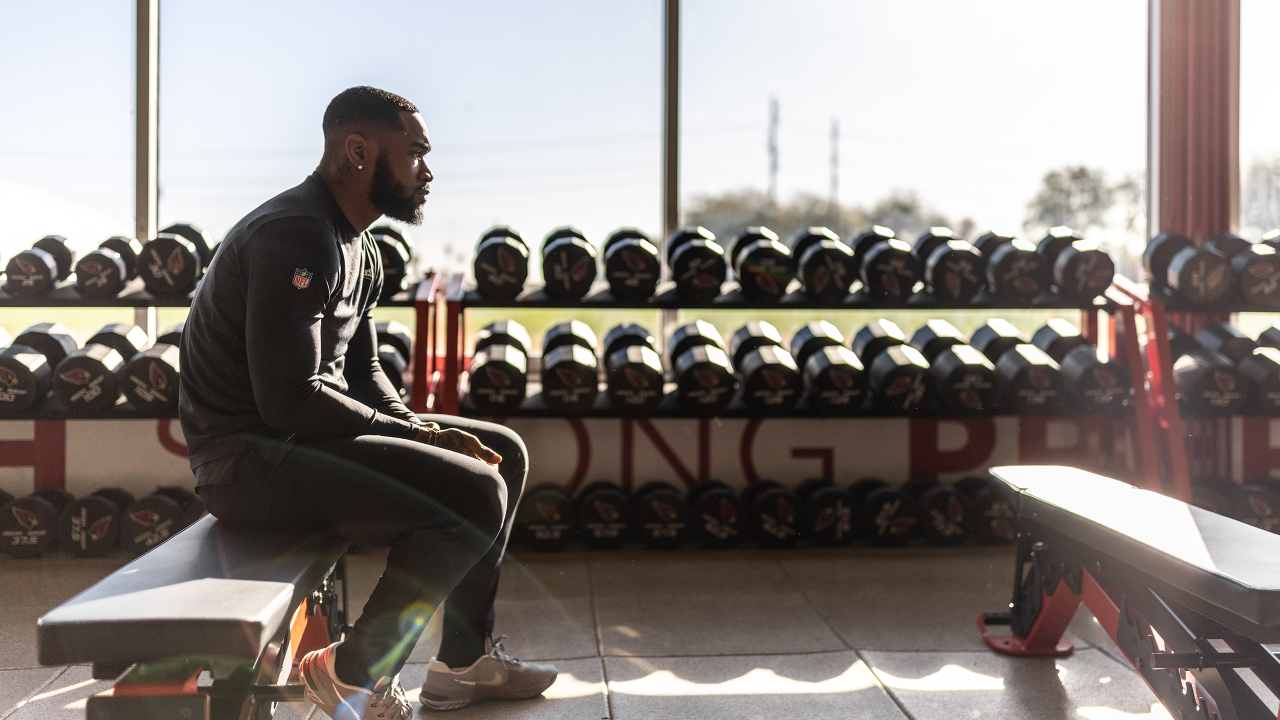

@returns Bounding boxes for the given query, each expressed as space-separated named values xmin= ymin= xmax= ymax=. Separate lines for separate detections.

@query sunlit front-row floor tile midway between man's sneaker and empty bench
xmin=605 ymin=652 xmax=904 ymax=720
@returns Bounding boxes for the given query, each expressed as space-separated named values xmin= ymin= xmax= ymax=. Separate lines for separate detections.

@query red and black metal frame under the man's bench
xmin=84 ymin=555 xmax=351 ymax=720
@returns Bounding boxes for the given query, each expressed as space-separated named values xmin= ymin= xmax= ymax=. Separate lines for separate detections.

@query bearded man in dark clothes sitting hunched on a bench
xmin=180 ymin=87 xmax=556 ymax=720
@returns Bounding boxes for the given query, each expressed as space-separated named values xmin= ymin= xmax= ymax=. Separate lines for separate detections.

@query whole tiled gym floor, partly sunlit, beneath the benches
xmin=0 ymin=547 xmax=1167 ymax=720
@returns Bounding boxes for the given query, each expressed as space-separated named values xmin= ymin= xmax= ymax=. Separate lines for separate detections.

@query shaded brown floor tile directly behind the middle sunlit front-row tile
xmin=589 ymin=552 xmax=847 ymax=656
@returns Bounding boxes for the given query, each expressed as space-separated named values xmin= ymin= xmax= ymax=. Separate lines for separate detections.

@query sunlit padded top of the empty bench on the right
xmin=991 ymin=466 xmax=1280 ymax=629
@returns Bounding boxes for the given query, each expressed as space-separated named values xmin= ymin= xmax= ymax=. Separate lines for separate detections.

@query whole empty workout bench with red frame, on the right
xmin=978 ymin=466 xmax=1280 ymax=720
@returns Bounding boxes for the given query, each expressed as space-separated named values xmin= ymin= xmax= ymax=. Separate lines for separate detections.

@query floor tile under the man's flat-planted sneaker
xmin=401 ymin=657 xmax=609 ymax=720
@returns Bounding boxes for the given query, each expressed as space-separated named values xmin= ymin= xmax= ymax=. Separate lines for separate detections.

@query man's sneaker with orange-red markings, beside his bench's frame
xmin=300 ymin=643 xmax=413 ymax=720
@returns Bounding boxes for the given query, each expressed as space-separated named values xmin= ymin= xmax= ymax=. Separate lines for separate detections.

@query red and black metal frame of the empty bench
xmin=978 ymin=497 xmax=1280 ymax=720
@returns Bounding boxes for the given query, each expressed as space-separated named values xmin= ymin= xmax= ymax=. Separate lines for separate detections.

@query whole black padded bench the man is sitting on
xmin=37 ymin=515 xmax=347 ymax=720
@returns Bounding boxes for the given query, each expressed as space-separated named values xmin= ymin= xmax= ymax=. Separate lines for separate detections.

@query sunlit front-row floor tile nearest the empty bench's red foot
xmin=863 ymin=648 xmax=1167 ymax=720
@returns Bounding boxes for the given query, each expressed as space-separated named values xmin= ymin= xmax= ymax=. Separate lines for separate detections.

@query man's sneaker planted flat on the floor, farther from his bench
xmin=419 ymin=635 xmax=558 ymax=710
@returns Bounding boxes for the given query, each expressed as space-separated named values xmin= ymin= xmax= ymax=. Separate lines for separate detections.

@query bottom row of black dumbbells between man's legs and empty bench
xmin=512 ymin=478 xmax=1014 ymax=551
